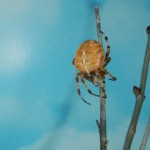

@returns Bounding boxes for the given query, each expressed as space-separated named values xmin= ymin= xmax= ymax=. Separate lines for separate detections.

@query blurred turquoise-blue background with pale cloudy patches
xmin=0 ymin=0 xmax=150 ymax=150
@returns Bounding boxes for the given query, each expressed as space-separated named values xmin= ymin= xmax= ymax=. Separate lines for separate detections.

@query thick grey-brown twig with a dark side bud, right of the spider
xmin=123 ymin=26 xmax=150 ymax=150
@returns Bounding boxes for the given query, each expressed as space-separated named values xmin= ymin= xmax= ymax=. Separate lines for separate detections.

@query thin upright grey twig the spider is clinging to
xmin=95 ymin=6 xmax=108 ymax=150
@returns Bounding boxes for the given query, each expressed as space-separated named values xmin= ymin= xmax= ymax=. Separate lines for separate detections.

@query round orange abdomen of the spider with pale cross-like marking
xmin=74 ymin=40 xmax=105 ymax=73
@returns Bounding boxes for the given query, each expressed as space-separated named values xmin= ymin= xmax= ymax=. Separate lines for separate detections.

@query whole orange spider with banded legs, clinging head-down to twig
xmin=72 ymin=31 xmax=116 ymax=105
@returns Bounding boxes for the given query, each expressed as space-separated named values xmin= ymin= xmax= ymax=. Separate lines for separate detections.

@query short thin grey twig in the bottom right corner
xmin=139 ymin=118 xmax=150 ymax=150
